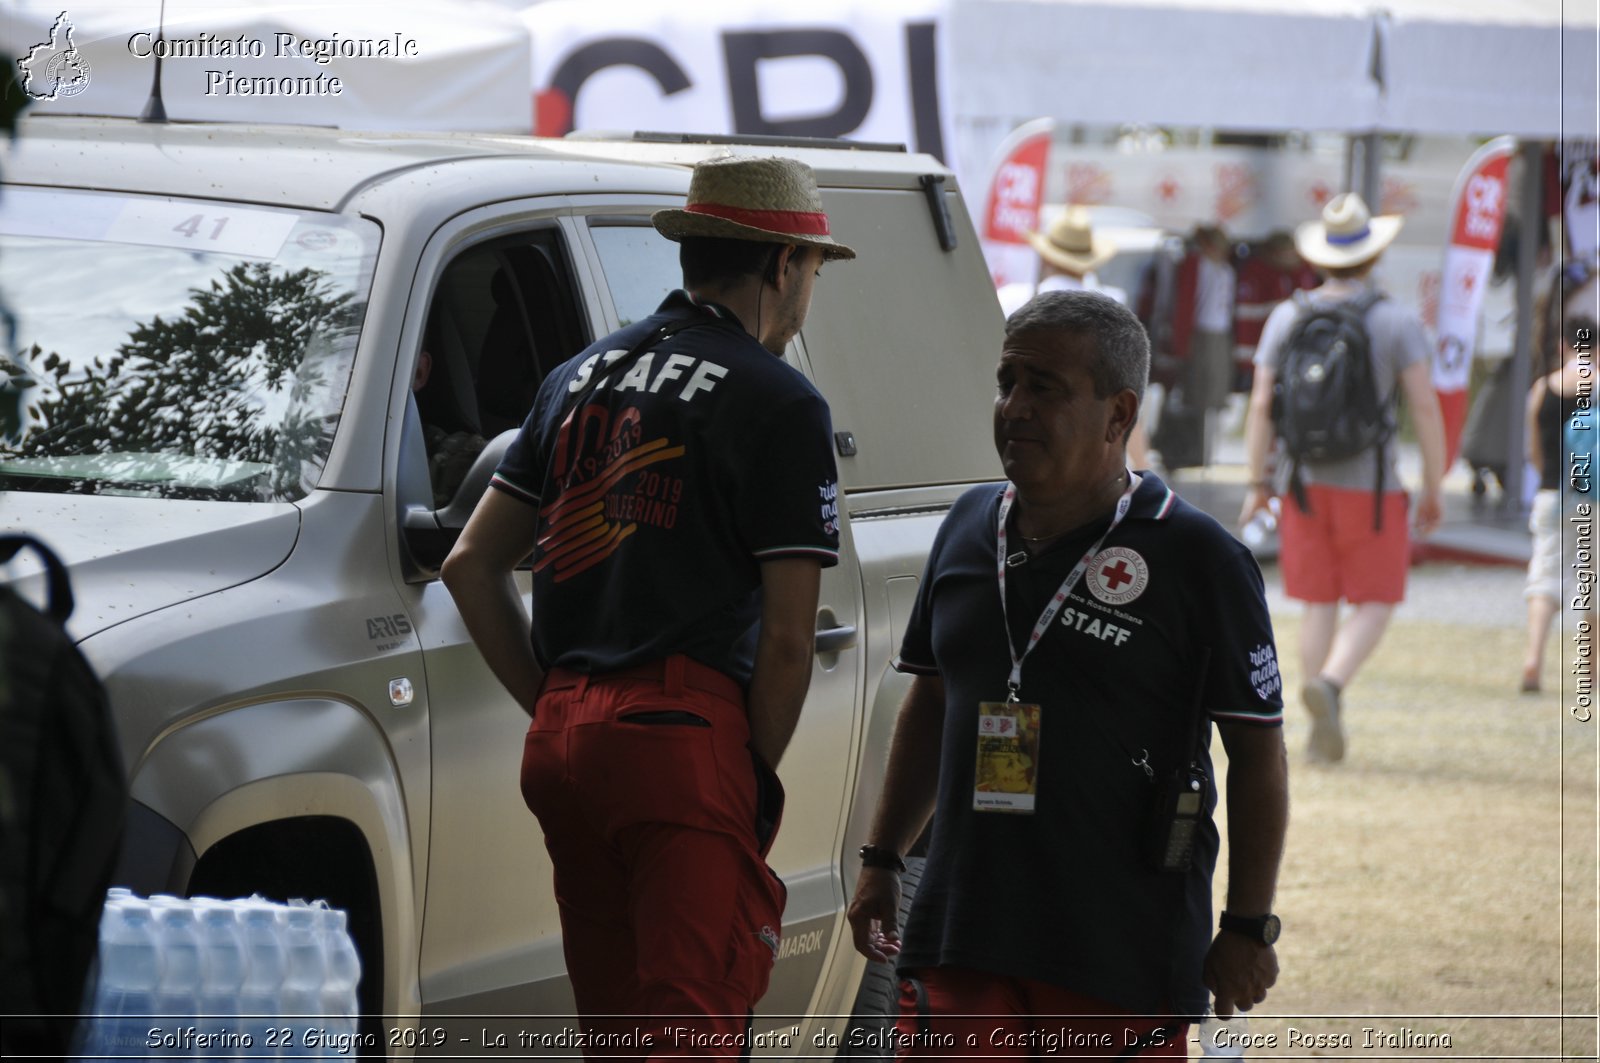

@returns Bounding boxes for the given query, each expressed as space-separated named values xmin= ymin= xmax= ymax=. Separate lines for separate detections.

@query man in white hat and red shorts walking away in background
xmin=1240 ymin=192 xmax=1445 ymax=762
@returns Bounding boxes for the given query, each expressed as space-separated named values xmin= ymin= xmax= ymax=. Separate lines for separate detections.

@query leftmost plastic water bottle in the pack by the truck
xmin=88 ymin=897 xmax=162 ymax=1060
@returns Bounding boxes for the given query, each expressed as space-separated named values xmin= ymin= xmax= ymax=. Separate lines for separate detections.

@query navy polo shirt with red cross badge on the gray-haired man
xmin=894 ymin=472 xmax=1283 ymax=1015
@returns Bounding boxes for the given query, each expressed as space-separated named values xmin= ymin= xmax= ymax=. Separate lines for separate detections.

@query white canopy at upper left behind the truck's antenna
xmin=0 ymin=0 xmax=533 ymax=133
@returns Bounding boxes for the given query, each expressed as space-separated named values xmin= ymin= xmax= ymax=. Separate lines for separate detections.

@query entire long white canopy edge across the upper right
xmin=947 ymin=0 xmax=1600 ymax=192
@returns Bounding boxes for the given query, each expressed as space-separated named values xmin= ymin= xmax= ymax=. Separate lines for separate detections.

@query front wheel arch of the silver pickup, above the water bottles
xmin=117 ymin=698 xmax=426 ymax=1030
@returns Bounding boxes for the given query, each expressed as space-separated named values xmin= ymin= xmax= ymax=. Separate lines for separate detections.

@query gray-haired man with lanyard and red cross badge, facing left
xmin=850 ymin=291 xmax=1288 ymax=1058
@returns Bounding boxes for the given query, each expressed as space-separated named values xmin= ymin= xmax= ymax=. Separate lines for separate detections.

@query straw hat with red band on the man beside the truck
xmin=650 ymin=157 xmax=856 ymax=258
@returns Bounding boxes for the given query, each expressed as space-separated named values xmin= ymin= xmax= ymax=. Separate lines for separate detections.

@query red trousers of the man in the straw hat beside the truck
xmin=522 ymin=656 xmax=784 ymax=1058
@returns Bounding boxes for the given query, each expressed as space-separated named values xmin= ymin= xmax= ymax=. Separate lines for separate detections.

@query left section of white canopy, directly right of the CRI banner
xmin=949 ymin=0 xmax=1378 ymax=130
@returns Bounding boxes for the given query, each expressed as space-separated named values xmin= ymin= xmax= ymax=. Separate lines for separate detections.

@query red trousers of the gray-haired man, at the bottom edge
xmin=894 ymin=967 xmax=1189 ymax=1060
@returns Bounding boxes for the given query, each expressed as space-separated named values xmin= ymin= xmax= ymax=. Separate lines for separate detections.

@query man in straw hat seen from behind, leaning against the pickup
xmin=443 ymin=157 xmax=854 ymax=1057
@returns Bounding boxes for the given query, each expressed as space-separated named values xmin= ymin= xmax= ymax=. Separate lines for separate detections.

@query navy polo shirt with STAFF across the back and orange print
xmin=491 ymin=291 xmax=838 ymax=684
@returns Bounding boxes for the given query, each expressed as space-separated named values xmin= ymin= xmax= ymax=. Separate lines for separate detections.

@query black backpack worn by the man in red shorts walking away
xmin=1272 ymin=290 xmax=1395 ymax=528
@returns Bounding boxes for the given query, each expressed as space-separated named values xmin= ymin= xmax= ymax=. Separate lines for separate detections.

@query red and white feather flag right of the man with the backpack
xmin=1434 ymin=136 xmax=1517 ymax=467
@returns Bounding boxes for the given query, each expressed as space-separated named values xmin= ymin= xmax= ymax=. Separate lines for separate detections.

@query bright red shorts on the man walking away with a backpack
xmin=1278 ymin=483 xmax=1411 ymax=604
